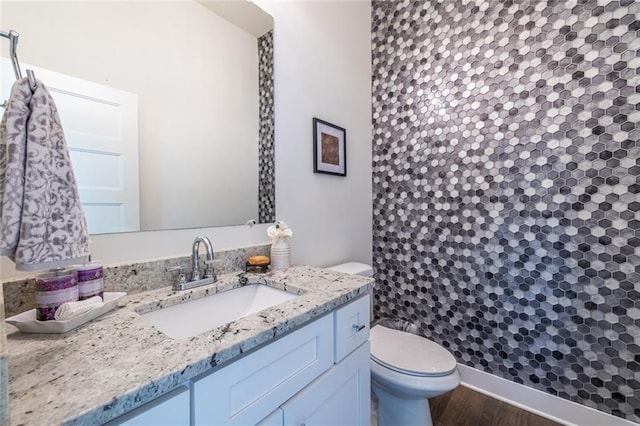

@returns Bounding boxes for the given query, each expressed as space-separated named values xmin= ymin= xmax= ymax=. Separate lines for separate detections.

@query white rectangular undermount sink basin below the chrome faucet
xmin=141 ymin=284 xmax=297 ymax=339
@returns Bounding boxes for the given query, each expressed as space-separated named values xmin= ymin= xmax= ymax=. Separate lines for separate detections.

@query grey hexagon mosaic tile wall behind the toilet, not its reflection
xmin=372 ymin=0 xmax=640 ymax=421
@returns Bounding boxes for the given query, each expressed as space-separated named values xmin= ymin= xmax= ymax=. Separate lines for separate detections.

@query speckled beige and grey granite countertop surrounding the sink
xmin=7 ymin=266 xmax=373 ymax=426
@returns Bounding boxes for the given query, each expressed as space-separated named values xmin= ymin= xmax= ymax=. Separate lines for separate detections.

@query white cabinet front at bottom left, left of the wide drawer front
xmin=107 ymin=386 xmax=191 ymax=426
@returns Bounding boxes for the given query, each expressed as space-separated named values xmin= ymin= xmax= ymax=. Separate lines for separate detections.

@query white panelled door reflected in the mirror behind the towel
xmin=0 ymin=58 xmax=140 ymax=234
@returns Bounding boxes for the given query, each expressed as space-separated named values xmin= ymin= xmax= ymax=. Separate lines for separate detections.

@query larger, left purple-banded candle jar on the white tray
xmin=36 ymin=269 xmax=78 ymax=321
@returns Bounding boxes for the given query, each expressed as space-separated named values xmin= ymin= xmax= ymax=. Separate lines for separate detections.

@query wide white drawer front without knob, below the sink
xmin=194 ymin=315 xmax=333 ymax=425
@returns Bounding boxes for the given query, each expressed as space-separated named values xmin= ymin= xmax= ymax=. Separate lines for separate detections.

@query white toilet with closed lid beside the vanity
xmin=327 ymin=262 xmax=460 ymax=426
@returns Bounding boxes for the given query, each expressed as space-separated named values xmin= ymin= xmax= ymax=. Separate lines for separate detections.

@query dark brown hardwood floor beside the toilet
xmin=371 ymin=386 xmax=561 ymax=426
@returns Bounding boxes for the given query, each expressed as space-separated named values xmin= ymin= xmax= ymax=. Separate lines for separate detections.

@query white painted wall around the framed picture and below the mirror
xmin=0 ymin=0 xmax=372 ymax=278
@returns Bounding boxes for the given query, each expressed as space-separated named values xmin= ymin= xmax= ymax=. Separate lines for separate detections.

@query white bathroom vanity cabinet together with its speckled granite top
xmin=8 ymin=267 xmax=373 ymax=425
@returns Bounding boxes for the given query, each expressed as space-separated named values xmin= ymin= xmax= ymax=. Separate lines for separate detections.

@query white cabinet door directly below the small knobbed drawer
xmin=282 ymin=342 xmax=371 ymax=426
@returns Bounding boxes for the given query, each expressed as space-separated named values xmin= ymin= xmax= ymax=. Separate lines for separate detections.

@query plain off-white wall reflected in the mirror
xmin=0 ymin=1 xmax=258 ymax=230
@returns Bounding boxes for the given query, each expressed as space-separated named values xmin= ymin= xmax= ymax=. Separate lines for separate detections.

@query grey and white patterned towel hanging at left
xmin=0 ymin=78 xmax=89 ymax=271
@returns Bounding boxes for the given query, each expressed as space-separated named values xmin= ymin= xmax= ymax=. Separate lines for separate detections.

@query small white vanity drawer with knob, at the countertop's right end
xmin=334 ymin=295 xmax=370 ymax=362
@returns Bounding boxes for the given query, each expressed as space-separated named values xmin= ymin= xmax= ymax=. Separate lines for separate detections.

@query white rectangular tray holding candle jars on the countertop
xmin=5 ymin=293 xmax=127 ymax=333
